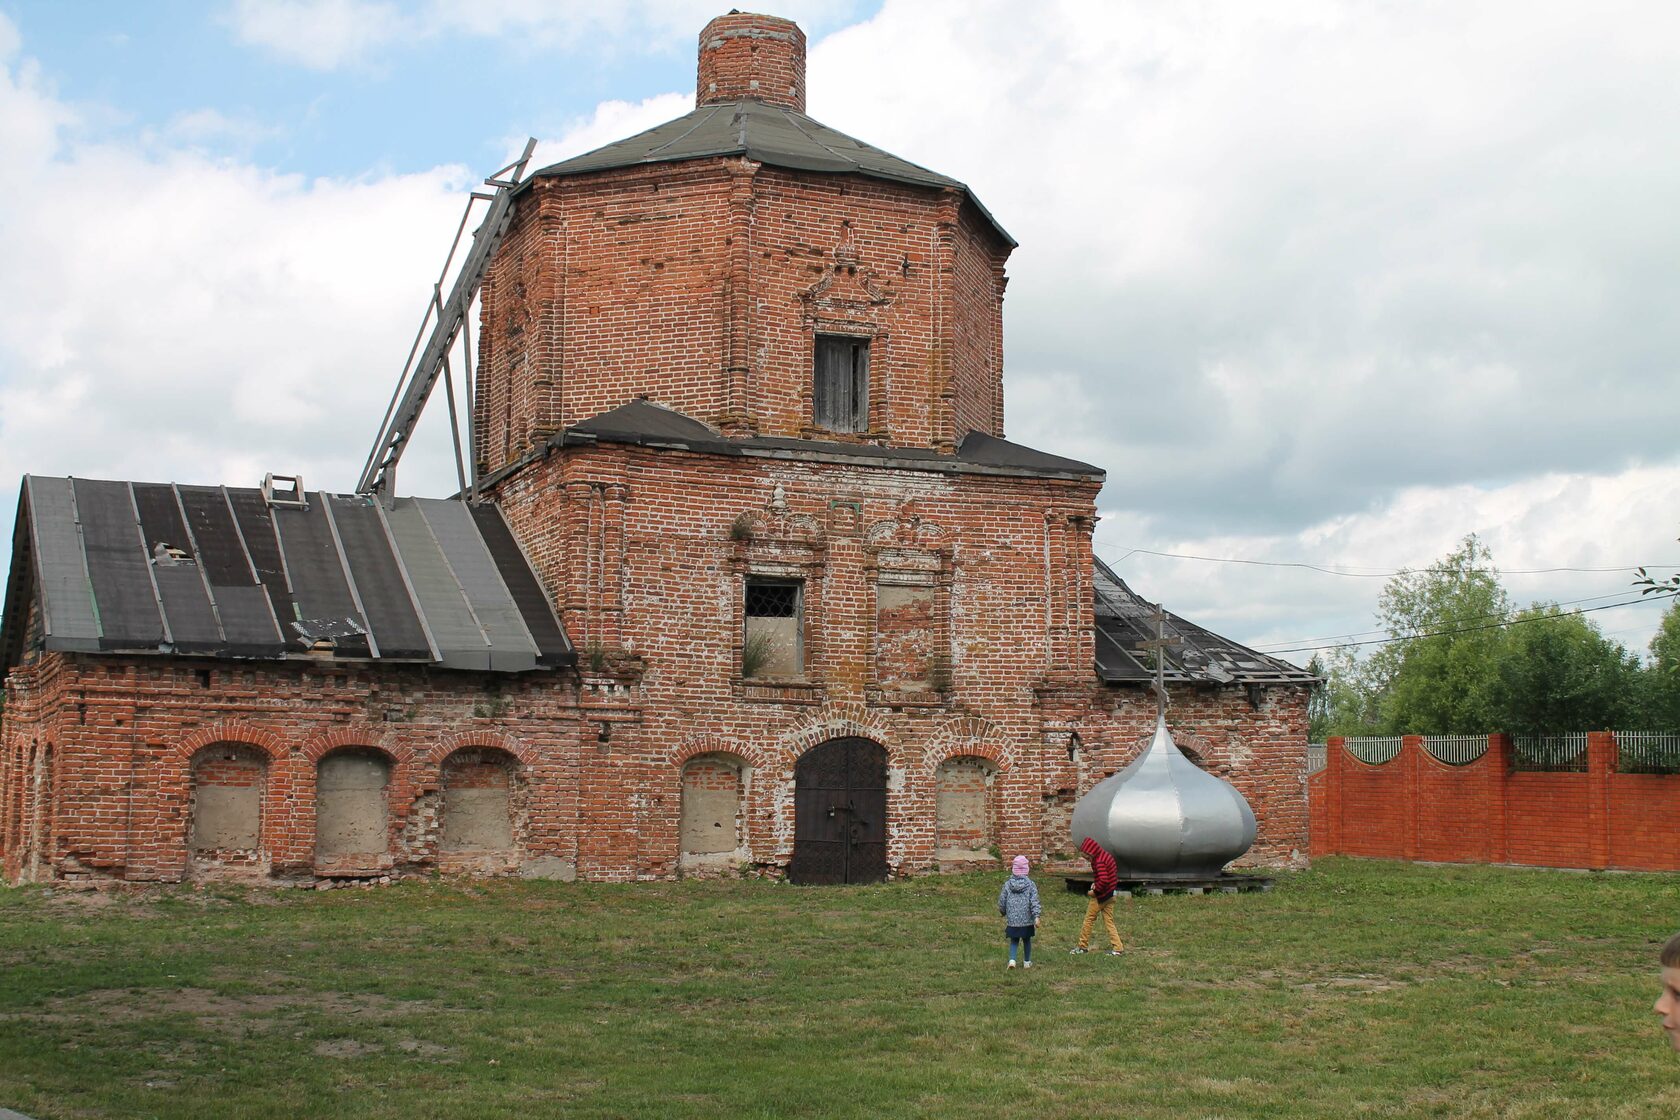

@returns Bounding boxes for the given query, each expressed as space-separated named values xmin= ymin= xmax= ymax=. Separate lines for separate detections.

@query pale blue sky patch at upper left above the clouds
xmin=0 ymin=0 xmax=879 ymax=178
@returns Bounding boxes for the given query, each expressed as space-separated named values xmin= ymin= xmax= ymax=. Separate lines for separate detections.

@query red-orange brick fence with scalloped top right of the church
xmin=1307 ymin=732 xmax=1680 ymax=871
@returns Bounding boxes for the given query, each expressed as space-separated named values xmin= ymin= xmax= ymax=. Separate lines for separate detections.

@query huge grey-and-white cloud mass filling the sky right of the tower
xmin=808 ymin=0 xmax=1680 ymax=658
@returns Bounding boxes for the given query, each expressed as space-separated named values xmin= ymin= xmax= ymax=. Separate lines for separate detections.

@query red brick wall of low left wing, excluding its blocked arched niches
xmin=0 ymin=653 xmax=594 ymax=882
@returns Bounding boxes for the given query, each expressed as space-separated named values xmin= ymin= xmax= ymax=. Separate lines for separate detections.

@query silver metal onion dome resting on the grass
xmin=1074 ymin=719 xmax=1255 ymax=878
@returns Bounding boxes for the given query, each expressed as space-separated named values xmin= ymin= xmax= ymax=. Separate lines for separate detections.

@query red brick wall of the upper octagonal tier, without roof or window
xmin=477 ymin=160 xmax=1008 ymax=470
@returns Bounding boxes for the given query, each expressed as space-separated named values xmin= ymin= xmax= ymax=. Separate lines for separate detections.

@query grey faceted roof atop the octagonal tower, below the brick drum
xmin=531 ymin=101 xmax=1015 ymax=247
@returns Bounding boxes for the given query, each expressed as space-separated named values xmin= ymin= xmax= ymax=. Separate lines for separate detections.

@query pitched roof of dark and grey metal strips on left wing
xmin=0 ymin=475 xmax=576 ymax=672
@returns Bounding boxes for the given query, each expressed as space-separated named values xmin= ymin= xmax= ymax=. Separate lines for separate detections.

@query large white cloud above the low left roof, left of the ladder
xmin=0 ymin=31 xmax=467 ymax=517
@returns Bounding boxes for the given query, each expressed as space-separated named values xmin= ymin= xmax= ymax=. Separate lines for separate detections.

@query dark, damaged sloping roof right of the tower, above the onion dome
xmin=1092 ymin=559 xmax=1317 ymax=685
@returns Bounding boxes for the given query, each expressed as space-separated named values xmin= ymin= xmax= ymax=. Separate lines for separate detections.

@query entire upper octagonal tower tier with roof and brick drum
xmin=474 ymin=12 xmax=1015 ymax=489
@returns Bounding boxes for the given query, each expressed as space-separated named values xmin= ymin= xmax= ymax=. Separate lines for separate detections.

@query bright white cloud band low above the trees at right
xmin=1095 ymin=465 xmax=1680 ymax=663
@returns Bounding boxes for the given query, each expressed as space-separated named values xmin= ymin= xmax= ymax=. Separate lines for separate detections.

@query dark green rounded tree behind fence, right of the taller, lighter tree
xmin=1485 ymin=603 xmax=1640 ymax=735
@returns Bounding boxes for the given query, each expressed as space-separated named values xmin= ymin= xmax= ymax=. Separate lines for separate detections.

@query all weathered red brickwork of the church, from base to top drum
xmin=0 ymin=15 xmax=1307 ymax=883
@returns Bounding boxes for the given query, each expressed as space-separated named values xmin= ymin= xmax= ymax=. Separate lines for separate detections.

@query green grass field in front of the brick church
xmin=0 ymin=860 xmax=1680 ymax=1120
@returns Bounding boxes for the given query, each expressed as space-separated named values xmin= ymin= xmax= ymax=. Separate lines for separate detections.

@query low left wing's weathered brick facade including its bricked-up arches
xmin=0 ymin=653 xmax=598 ymax=882
